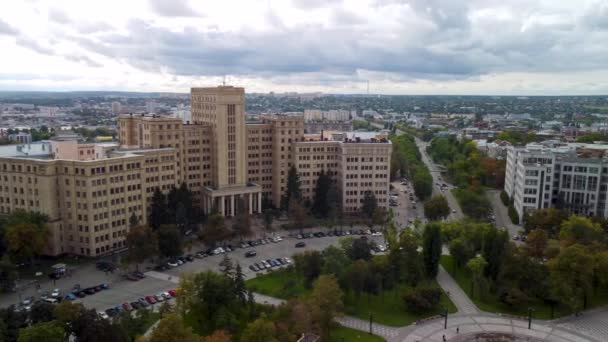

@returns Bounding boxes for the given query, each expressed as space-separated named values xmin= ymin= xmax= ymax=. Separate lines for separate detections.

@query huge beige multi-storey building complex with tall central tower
xmin=0 ymin=86 xmax=392 ymax=256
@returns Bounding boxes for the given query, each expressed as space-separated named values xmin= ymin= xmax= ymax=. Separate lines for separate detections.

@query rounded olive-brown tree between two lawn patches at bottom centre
xmin=310 ymin=275 xmax=344 ymax=340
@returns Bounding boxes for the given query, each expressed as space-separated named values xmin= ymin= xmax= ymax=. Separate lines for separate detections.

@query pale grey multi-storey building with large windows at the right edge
xmin=505 ymin=143 xmax=608 ymax=217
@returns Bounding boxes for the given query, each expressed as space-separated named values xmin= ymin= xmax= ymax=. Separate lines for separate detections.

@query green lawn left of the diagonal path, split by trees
xmin=247 ymin=269 xmax=456 ymax=327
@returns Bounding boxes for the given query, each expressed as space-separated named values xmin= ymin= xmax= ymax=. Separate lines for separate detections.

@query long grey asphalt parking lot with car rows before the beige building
xmin=2 ymin=235 xmax=384 ymax=311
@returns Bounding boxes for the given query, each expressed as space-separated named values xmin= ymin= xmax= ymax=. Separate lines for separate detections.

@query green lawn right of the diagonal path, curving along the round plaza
xmin=441 ymin=255 xmax=608 ymax=319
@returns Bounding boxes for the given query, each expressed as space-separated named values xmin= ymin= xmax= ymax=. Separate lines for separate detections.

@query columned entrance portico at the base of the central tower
xmin=203 ymin=183 xmax=262 ymax=216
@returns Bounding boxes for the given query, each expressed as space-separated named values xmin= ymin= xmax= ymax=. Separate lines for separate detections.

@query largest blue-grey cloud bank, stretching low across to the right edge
xmin=65 ymin=0 xmax=608 ymax=80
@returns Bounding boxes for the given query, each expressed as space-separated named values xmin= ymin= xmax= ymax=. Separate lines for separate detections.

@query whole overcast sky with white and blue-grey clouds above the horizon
xmin=0 ymin=0 xmax=608 ymax=95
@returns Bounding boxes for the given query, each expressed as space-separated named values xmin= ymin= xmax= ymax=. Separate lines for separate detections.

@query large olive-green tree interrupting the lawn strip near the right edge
xmin=549 ymin=244 xmax=593 ymax=311
